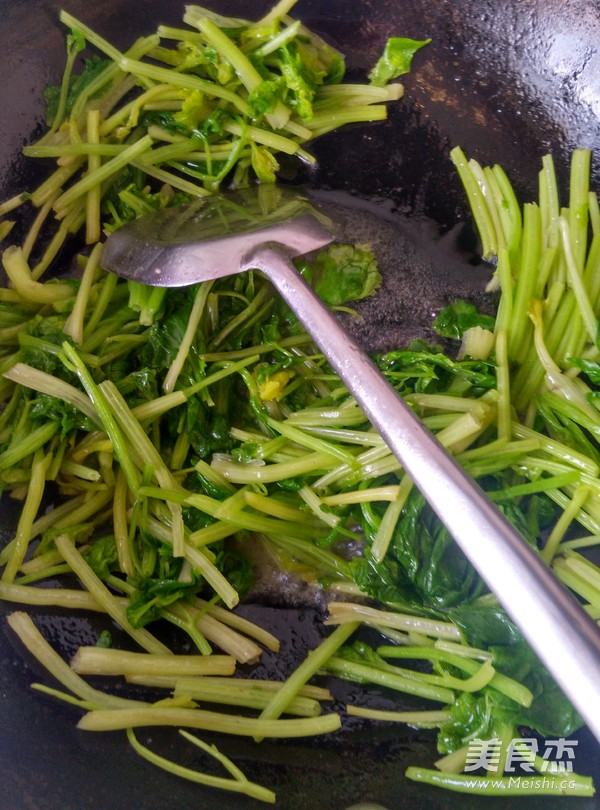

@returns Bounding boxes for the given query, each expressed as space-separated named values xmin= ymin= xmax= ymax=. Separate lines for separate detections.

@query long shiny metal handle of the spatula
xmin=251 ymin=246 xmax=600 ymax=740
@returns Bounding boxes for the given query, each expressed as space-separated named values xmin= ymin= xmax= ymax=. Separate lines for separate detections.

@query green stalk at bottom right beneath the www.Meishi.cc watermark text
xmin=405 ymin=766 xmax=595 ymax=796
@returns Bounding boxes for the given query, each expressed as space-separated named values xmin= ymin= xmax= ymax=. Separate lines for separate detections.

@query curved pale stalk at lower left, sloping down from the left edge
xmin=7 ymin=612 xmax=147 ymax=709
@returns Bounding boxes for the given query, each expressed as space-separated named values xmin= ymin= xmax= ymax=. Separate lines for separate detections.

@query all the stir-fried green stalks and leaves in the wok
xmin=0 ymin=2 xmax=600 ymax=802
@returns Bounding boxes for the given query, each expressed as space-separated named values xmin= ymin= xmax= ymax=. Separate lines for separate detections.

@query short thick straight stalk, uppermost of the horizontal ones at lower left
xmin=71 ymin=646 xmax=235 ymax=678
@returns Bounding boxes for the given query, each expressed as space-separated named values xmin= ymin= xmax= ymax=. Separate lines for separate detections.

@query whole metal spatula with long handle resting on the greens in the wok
xmin=102 ymin=186 xmax=600 ymax=739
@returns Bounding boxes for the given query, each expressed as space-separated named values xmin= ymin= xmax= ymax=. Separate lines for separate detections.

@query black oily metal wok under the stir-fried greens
xmin=0 ymin=0 xmax=600 ymax=810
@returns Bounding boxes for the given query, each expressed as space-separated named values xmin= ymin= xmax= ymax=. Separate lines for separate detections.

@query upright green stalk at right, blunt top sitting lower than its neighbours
xmin=508 ymin=203 xmax=541 ymax=360
